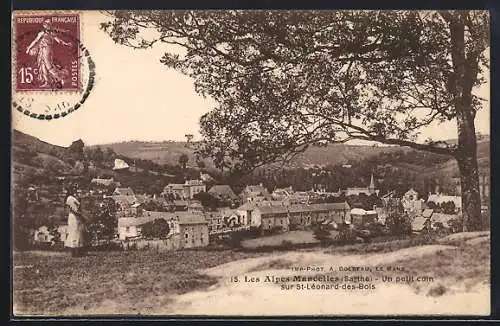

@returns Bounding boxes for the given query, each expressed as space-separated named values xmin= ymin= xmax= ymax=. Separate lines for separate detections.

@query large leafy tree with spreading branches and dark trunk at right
xmin=101 ymin=10 xmax=489 ymax=230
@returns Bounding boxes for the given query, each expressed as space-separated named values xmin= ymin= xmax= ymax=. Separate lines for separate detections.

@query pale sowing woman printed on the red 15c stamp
xmin=26 ymin=19 xmax=71 ymax=87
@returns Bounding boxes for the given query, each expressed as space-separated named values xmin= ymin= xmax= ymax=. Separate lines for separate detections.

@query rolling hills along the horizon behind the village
xmin=13 ymin=131 xmax=490 ymax=191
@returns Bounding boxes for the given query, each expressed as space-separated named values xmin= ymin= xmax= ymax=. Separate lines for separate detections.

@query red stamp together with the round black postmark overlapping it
xmin=12 ymin=11 xmax=95 ymax=120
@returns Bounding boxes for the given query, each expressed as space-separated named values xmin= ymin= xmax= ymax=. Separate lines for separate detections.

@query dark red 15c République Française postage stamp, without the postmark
xmin=13 ymin=14 xmax=82 ymax=91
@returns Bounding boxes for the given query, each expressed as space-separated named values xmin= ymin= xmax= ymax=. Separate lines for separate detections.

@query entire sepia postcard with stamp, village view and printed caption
xmin=11 ymin=10 xmax=491 ymax=317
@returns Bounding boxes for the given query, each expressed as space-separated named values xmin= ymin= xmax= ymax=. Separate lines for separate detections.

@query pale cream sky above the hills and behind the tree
xmin=12 ymin=11 xmax=490 ymax=146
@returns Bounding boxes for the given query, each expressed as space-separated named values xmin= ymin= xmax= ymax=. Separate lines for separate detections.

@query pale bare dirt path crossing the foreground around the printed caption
xmin=155 ymin=245 xmax=490 ymax=316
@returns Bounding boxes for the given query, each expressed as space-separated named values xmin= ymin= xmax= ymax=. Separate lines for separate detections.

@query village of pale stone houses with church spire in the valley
xmin=30 ymin=160 xmax=489 ymax=250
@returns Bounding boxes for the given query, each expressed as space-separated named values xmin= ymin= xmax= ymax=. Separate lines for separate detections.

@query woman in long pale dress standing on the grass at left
xmin=65 ymin=185 xmax=86 ymax=257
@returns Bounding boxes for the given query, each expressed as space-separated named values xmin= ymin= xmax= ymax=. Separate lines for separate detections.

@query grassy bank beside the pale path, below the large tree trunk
xmin=286 ymin=234 xmax=491 ymax=296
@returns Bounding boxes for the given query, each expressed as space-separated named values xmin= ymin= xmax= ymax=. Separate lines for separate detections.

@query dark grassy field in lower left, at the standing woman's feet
xmin=14 ymin=250 xmax=262 ymax=315
